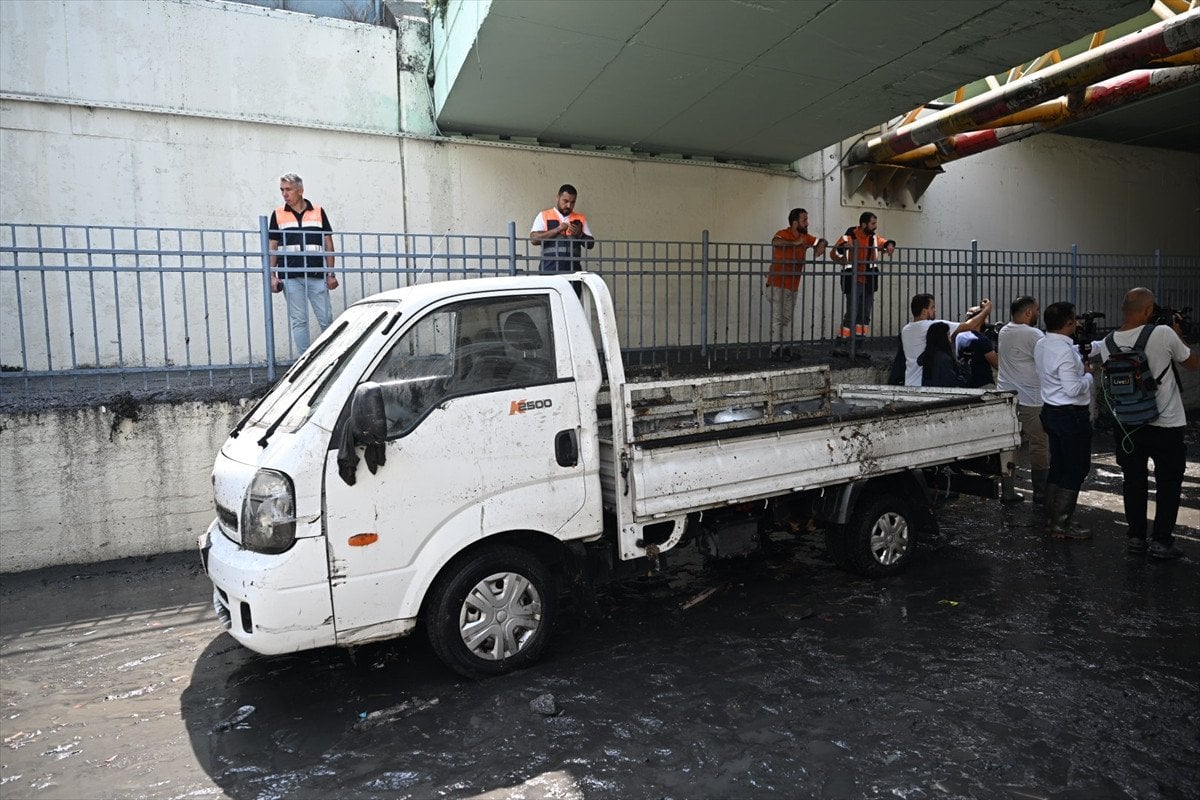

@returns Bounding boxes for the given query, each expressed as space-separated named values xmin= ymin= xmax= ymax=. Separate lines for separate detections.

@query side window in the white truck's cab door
xmin=368 ymin=294 xmax=558 ymax=438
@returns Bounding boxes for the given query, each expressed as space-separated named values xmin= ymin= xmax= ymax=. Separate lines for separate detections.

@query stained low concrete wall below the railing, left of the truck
xmin=0 ymin=403 xmax=245 ymax=572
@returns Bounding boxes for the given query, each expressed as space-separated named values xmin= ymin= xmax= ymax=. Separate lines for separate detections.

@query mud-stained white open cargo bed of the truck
xmin=601 ymin=367 xmax=1020 ymax=522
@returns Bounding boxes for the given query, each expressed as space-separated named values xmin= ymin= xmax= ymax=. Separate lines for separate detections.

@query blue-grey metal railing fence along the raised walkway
xmin=0 ymin=217 xmax=1200 ymax=390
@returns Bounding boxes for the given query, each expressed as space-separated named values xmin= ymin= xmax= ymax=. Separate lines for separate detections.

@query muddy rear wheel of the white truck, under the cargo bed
xmin=827 ymin=493 xmax=916 ymax=578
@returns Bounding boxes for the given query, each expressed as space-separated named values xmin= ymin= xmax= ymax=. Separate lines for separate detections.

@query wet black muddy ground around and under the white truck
xmin=0 ymin=435 xmax=1200 ymax=800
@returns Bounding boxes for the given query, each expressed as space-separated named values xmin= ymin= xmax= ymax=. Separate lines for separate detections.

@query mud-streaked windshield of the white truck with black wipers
xmin=239 ymin=303 xmax=390 ymax=429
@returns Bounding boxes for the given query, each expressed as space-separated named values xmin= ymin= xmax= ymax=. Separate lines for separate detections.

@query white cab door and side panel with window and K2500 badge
xmin=325 ymin=290 xmax=588 ymax=642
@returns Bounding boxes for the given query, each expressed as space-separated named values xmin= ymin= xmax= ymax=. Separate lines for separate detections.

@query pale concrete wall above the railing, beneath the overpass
xmin=0 ymin=0 xmax=1200 ymax=254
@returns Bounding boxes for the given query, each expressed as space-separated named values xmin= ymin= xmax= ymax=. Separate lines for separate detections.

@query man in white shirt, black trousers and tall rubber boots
xmin=1033 ymin=302 xmax=1092 ymax=540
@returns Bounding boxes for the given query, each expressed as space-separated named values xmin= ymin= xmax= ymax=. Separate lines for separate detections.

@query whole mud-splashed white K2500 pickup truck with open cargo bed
xmin=200 ymin=273 xmax=1019 ymax=675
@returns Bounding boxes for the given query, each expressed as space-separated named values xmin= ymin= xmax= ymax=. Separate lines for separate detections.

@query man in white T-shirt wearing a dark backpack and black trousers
xmin=1100 ymin=288 xmax=1200 ymax=560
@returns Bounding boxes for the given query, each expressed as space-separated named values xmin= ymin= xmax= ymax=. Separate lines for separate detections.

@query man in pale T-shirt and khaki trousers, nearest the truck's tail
xmin=996 ymin=295 xmax=1050 ymax=504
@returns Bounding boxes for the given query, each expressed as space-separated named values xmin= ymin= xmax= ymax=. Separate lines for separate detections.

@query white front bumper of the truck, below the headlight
xmin=199 ymin=521 xmax=336 ymax=655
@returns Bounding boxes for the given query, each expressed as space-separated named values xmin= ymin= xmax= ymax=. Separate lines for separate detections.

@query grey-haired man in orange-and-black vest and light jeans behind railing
xmin=268 ymin=173 xmax=337 ymax=355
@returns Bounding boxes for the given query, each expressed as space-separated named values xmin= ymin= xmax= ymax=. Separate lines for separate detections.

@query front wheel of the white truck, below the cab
xmin=425 ymin=547 xmax=557 ymax=678
